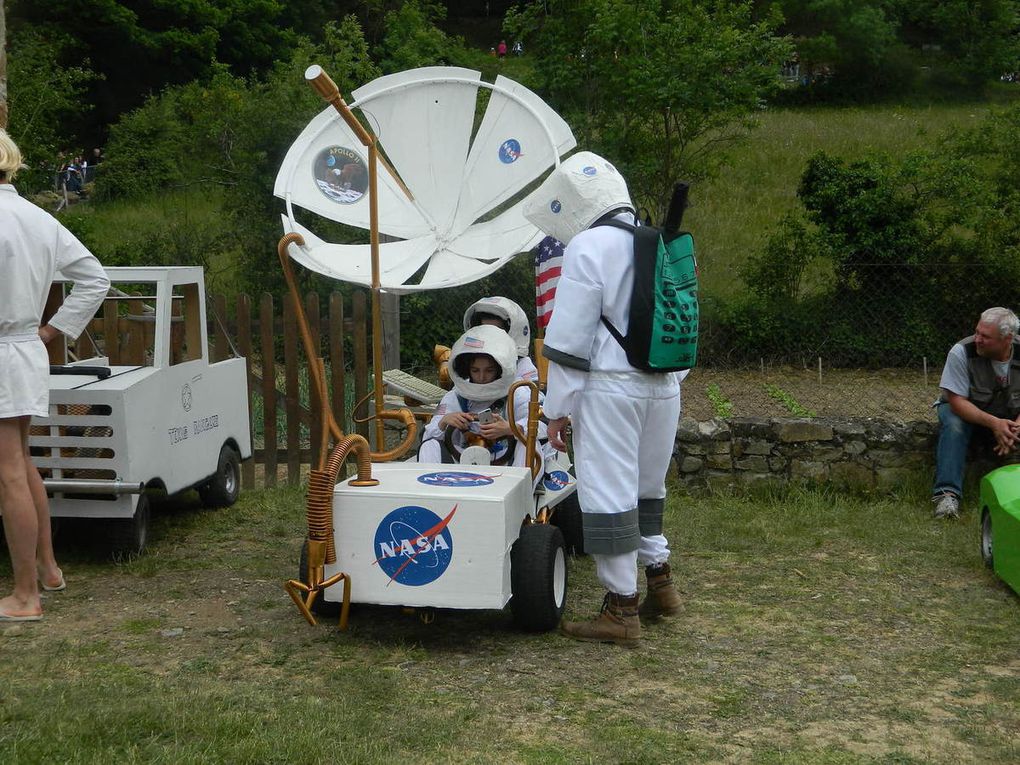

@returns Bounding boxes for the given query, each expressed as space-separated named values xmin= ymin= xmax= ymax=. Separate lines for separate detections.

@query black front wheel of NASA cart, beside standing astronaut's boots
xmin=510 ymin=523 xmax=567 ymax=632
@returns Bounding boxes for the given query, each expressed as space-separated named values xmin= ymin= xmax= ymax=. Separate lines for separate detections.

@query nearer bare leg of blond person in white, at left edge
xmin=0 ymin=417 xmax=42 ymax=616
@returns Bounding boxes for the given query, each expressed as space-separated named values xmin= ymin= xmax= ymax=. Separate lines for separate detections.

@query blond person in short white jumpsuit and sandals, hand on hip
xmin=0 ymin=130 xmax=110 ymax=622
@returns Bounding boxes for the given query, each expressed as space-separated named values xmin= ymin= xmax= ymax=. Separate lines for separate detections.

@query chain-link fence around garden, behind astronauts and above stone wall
xmin=387 ymin=256 xmax=1016 ymax=421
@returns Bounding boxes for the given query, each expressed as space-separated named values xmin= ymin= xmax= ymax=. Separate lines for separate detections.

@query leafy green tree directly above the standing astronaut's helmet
xmin=506 ymin=0 xmax=789 ymax=219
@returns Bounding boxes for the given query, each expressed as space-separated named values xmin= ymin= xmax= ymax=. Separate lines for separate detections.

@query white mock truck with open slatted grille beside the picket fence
xmin=29 ymin=267 xmax=252 ymax=554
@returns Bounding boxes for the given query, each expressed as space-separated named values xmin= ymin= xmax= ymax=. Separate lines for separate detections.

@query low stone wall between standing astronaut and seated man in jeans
xmin=673 ymin=417 xmax=937 ymax=492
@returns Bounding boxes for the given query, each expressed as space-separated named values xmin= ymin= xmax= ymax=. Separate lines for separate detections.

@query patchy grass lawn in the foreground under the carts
xmin=0 ymin=481 xmax=1020 ymax=763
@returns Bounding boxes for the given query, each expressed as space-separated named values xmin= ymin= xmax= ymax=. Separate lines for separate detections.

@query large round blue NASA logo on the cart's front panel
xmin=374 ymin=505 xmax=457 ymax=588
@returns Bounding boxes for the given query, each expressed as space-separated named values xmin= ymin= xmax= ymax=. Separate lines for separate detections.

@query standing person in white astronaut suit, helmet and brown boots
xmin=524 ymin=152 xmax=680 ymax=646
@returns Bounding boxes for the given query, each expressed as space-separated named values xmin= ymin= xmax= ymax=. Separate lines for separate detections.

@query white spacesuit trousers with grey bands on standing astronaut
xmin=571 ymin=371 xmax=680 ymax=596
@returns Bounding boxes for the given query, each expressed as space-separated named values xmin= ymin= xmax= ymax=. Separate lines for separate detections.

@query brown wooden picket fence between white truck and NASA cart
xmin=208 ymin=292 xmax=370 ymax=489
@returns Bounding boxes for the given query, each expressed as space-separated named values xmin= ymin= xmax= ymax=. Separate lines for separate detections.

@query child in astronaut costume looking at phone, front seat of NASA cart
xmin=418 ymin=324 xmax=552 ymax=477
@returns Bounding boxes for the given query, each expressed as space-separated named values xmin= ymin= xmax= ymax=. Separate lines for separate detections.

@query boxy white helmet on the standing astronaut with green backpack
xmin=524 ymin=151 xmax=634 ymax=245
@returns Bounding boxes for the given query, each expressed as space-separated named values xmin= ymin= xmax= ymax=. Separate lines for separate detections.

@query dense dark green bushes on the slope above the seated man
xmin=726 ymin=106 xmax=1020 ymax=364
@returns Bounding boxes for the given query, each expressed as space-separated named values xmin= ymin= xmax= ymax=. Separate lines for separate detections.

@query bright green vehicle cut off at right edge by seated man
xmin=981 ymin=465 xmax=1020 ymax=594
